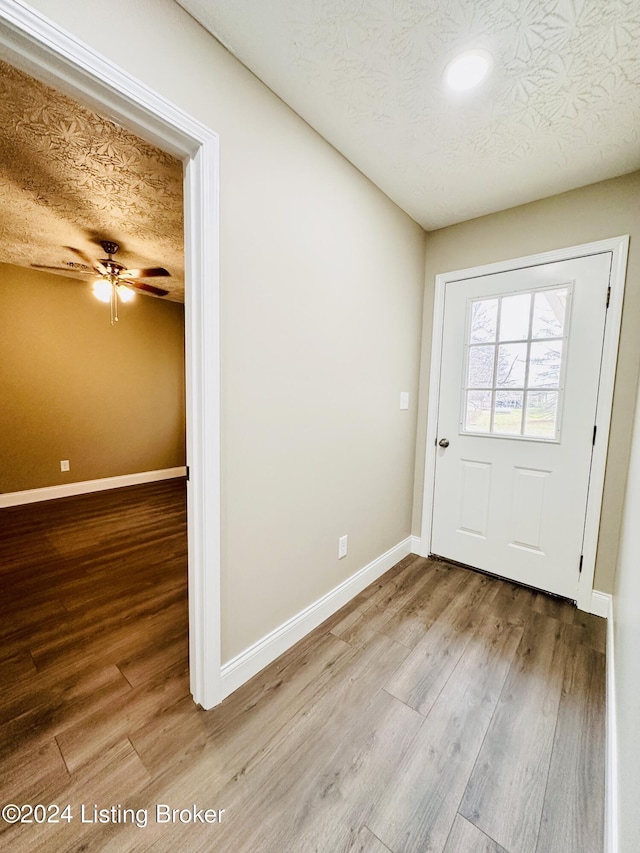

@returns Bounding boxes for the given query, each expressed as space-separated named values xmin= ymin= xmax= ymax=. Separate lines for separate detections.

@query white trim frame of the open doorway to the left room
xmin=0 ymin=0 xmax=223 ymax=708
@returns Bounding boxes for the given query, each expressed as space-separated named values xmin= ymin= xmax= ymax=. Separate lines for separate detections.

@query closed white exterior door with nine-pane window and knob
xmin=431 ymin=252 xmax=612 ymax=599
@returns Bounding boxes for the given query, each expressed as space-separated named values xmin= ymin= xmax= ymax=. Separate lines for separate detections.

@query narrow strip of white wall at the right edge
xmin=613 ymin=374 xmax=640 ymax=853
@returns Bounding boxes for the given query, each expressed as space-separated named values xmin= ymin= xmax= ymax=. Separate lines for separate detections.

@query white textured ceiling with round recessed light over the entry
xmin=180 ymin=0 xmax=640 ymax=230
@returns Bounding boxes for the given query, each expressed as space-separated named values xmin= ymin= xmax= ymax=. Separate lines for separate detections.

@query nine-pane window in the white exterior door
xmin=461 ymin=284 xmax=571 ymax=441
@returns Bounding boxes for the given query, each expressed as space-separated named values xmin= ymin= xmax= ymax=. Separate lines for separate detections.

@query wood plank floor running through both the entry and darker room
xmin=0 ymin=481 xmax=605 ymax=853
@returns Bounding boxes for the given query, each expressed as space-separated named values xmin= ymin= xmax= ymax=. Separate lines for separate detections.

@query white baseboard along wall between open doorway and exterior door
xmin=221 ymin=536 xmax=412 ymax=698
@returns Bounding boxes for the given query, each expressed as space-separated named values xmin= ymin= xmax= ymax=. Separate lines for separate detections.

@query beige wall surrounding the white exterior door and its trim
xmin=413 ymin=172 xmax=640 ymax=593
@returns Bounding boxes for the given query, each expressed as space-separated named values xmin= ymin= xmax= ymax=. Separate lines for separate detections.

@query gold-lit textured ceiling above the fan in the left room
xmin=0 ymin=57 xmax=184 ymax=301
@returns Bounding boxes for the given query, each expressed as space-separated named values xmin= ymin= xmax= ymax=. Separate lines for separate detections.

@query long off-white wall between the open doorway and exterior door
xmin=22 ymin=0 xmax=425 ymax=660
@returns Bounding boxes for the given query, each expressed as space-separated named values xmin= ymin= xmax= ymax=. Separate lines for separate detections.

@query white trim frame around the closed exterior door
xmin=420 ymin=235 xmax=629 ymax=612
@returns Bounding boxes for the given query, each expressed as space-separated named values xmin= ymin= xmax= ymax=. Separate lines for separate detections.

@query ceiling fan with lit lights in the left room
xmin=31 ymin=240 xmax=171 ymax=326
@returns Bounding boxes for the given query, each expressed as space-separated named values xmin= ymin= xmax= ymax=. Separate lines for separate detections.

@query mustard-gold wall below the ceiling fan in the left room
xmin=0 ymin=264 xmax=185 ymax=492
